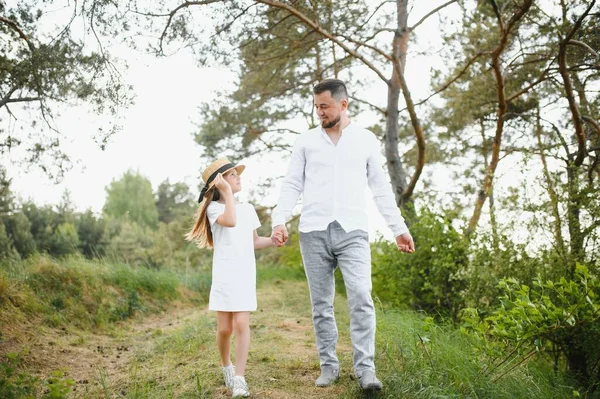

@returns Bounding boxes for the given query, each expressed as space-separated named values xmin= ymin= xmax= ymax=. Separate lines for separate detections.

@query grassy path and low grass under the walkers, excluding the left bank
xmin=68 ymin=268 xmax=574 ymax=399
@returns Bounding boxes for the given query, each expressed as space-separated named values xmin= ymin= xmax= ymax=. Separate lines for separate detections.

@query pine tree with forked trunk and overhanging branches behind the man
xmin=110 ymin=0 xmax=466 ymax=216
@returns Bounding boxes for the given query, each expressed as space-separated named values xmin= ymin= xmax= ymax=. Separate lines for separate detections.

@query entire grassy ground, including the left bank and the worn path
xmin=0 ymin=257 xmax=576 ymax=399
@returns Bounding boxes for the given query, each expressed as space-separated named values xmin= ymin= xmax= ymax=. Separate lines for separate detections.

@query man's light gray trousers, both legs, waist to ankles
xmin=300 ymin=222 xmax=375 ymax=376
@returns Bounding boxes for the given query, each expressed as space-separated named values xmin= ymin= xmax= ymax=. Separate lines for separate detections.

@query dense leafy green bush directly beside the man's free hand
xmin=372 ymin=210 xmax=468 ymax=319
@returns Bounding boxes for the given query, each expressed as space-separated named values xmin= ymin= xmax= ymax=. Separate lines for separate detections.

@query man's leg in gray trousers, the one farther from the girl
xmin=332 ymin=227 xmax=375 ymax=384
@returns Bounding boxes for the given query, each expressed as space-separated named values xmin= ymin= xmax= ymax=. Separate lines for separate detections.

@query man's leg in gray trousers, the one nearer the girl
xmin=300 ymin=229 xmax=339 ymax=386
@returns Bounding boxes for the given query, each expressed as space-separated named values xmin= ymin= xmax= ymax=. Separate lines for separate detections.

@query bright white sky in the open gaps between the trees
xmin=3 ymin=1 xmax=464 ymax=239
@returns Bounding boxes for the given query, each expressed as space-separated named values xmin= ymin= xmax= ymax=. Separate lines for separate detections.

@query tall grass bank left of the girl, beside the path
xmin=0 ymin=256 xmax=210 ymax=329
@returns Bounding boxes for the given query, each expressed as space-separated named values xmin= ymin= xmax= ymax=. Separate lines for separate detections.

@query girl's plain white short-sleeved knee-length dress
xmin=206 ymin=201 xmax=260 ymax=312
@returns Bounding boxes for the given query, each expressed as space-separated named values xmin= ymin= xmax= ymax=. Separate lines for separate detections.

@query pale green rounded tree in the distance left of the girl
xmin=104 ymin=170 xmax=158 ymax=228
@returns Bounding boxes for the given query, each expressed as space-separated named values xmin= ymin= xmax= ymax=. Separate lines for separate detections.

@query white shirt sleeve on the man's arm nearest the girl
xmin=271 ymin=136 xmax=306 ymax=227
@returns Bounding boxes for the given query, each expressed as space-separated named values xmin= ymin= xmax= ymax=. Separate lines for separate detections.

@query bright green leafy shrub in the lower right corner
xmin=463 ymin=265 xmax=600 ymax=389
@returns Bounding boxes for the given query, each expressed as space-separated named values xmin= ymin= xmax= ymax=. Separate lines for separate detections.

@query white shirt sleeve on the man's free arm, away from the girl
xmin=367 ymin=136 xmax=408 ymax=237
